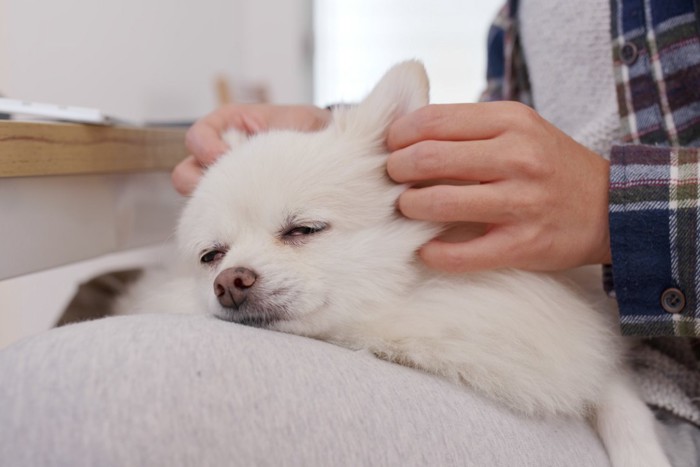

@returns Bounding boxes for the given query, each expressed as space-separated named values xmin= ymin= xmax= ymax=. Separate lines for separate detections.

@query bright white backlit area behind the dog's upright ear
xmin=314 ymin=0 xmax=505 ymax=105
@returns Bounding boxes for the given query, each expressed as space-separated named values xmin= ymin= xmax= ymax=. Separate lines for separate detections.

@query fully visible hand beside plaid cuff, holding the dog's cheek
xmin=387 ymin=102 xmax=611 ymax=272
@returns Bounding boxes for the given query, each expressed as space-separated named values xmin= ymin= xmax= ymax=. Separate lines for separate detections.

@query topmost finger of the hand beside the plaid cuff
xmin=387 ymin=102 xmax=532 ymax=150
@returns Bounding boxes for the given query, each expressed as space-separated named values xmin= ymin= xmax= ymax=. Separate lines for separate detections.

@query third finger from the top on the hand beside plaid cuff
xmin=398 ymin=184 xmax=513 ymax=224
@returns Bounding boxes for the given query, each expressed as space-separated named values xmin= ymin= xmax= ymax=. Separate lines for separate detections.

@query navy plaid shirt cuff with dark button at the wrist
xmin=610 ymin=145 xmax=700 ymax=337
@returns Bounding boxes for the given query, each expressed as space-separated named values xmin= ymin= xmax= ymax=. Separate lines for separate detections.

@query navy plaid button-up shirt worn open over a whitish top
xmin=482 ymin=0 xmax=700 ymax=337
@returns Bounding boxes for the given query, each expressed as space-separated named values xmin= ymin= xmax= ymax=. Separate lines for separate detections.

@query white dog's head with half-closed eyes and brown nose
xmin=178 ymin=62 xmax=437 ymax=335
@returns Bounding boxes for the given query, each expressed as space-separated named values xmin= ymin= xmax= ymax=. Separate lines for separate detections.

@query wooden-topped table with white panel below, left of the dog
xmin=0 ymin=121 xmax=187 ymax=280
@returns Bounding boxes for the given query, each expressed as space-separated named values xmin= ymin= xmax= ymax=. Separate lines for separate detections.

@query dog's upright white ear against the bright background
xmin=334 ymin=60 xmax=429 ymax=142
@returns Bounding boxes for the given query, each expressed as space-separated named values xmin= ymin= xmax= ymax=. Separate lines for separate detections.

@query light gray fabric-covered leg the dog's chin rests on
xmin=0 ymin=315 xmax=608 ymax=467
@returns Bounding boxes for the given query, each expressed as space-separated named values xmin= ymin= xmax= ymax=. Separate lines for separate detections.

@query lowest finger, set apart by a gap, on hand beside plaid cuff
xmin=418 ymin=230 xmax=515 ymax=273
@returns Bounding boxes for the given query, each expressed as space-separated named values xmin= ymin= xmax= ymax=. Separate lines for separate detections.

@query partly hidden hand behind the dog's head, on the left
xmin=172 ymin=104 xmax=330 ymax=195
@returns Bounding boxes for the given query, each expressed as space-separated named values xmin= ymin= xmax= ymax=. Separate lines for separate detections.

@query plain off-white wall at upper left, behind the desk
xmin=0 ymin=0 xmax=311 ymax=120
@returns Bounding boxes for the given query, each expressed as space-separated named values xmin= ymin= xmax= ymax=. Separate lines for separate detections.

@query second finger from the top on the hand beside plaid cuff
xmin=387 ymin=140 xmax=506 ymax=183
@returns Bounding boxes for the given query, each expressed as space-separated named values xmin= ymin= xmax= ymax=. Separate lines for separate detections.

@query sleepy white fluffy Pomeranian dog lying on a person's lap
xmin=130 ymin=62 xmax=670 ymax=467
